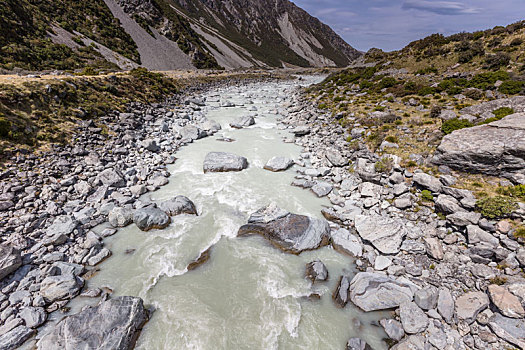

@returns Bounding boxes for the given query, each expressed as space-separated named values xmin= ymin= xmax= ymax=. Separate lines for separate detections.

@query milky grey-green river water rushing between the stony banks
xmin=58 ymin=79 xmax=386 ymax=350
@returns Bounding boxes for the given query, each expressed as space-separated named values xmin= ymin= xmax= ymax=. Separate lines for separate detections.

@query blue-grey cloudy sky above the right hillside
xmin=292 ymin=0 xmax=525 ymax=51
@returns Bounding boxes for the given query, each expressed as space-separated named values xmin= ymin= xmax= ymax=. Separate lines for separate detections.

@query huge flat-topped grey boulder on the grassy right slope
xmin=433 ymin=113 xmax=525 ymax=176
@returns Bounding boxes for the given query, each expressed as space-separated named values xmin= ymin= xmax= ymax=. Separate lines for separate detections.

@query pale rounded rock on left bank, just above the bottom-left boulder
xmin=40 ymin=274 xmax=84 ymax=303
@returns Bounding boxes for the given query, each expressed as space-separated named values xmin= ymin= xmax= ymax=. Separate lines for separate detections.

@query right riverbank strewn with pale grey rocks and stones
xmin=282 ymin=89 xmax=525 ymax=349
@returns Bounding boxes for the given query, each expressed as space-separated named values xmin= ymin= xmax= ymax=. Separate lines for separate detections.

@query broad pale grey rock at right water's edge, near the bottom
xmin=350 ymin=272 xmax=414 ymax=312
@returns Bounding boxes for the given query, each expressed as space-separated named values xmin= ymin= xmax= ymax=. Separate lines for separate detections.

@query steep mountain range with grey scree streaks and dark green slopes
xmin=0 ymin=0 xmax=361 ymax=70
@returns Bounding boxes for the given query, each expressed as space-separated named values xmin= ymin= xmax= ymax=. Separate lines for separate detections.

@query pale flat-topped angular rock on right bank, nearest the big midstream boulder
xmin=355 ymin=215 xmax=408 ymax=254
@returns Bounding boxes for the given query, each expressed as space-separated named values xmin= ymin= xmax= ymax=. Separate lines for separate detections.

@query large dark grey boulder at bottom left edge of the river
xmin=37 ymin=297 xmax=148 ymax=350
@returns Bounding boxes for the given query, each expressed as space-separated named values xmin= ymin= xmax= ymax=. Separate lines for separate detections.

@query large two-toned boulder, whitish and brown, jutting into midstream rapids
xmin=238 ymin=204 xmax=330 ymax=254
